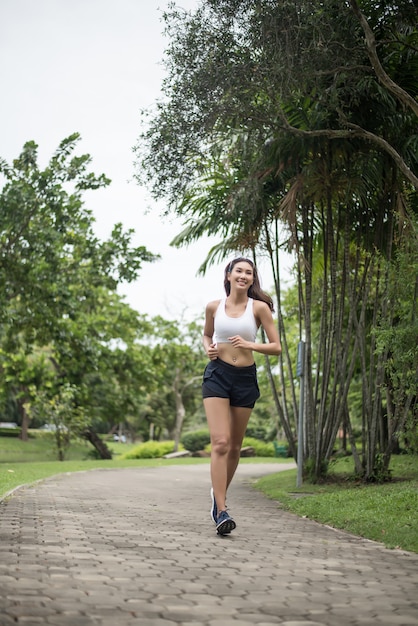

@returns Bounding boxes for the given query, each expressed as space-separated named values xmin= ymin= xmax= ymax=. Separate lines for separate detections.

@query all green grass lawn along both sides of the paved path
xmin=0 ymin=437 xmax=418 ymax=553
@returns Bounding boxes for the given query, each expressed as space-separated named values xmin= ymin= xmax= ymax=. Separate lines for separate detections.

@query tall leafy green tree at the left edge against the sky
xmin=0 ymin=133 xmax=158 ymax=448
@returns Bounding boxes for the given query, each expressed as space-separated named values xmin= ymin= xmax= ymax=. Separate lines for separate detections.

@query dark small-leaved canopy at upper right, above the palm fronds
xmin=137 ymin=0 xmax=417 ymax=200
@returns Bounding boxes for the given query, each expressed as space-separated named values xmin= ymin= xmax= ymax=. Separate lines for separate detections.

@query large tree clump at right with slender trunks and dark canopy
xmin=137 ymin=0 xmax=418 ymax=480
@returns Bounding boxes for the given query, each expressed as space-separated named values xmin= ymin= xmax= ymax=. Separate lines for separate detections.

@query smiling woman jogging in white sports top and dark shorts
xmin=202 ymin=257 xmax=281 ymax=535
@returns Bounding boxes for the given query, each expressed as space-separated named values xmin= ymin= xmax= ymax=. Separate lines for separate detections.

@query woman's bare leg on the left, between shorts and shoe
xmin=203 ymin=398 xmax=231 ymax=511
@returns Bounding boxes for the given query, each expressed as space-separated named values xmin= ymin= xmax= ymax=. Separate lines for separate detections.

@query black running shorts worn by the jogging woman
xmin=202 ymin=359 xmax=260 ymax=409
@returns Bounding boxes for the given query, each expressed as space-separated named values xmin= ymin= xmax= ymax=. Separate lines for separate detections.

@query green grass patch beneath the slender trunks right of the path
xmin=255 ymin=455 xmax=418 ymax=552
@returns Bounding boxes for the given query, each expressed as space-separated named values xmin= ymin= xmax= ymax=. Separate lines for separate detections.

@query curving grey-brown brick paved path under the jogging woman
xmin=0 ymin=464 xmax=418 ymax=626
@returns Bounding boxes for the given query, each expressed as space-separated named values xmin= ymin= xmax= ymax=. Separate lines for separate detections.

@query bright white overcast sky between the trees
xmin=0 ymin=0 xmax=294 ymax=319
